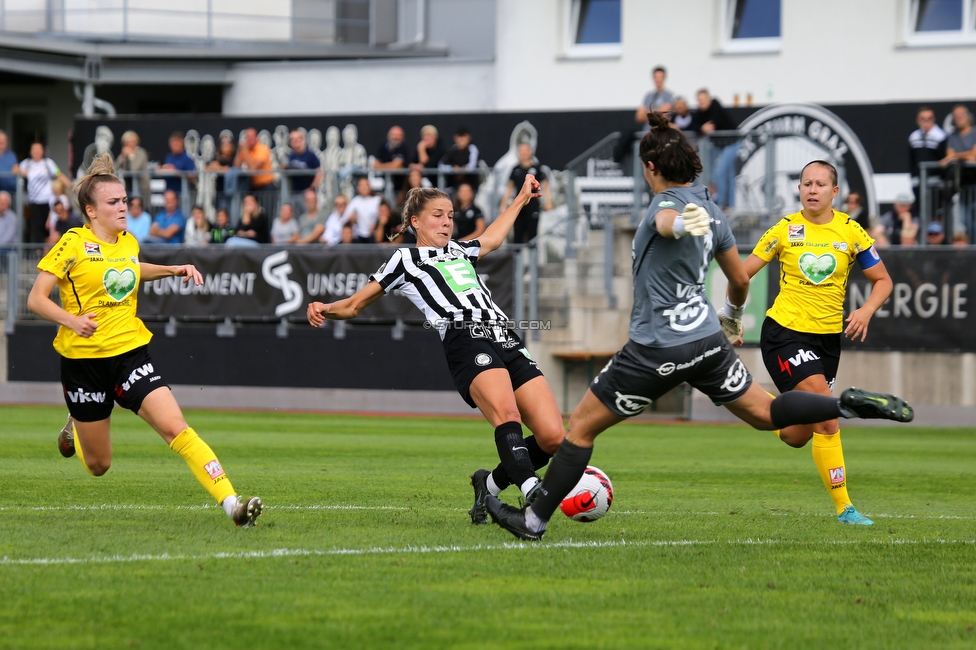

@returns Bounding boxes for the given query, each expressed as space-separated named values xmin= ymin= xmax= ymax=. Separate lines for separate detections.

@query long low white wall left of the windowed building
xmin=223 ymin=58 xmax=494 ymax=116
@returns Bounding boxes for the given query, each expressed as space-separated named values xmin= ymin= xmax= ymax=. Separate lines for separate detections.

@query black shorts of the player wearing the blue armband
xmin=759 ymin=317 xmax=840 ymax=393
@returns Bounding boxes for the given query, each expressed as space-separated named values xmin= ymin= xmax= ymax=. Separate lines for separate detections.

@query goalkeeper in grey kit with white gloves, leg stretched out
xmin=487 ymin=113 xmax=914 ymax=540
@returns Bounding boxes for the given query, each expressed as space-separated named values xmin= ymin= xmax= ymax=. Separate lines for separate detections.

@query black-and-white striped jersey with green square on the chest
xmin=370 ymin=239 xmax=508 ymax=339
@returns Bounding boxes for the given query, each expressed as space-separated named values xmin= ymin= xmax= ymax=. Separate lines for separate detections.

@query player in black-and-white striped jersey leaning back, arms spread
xmin=308 ymin=175 xmax=565 ymax=524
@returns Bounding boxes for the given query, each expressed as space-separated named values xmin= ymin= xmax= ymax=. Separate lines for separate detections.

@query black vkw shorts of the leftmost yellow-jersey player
xmin=61 ymin=345 xmax=168 ymax=422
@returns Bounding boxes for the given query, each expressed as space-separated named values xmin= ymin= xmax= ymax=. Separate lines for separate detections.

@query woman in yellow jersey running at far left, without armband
xmin=27 ymin=154 xmax=263 ymax=526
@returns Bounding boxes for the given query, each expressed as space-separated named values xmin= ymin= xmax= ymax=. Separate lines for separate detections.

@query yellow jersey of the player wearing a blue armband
xmin=752 ymin=210 xmax=881 ymax=334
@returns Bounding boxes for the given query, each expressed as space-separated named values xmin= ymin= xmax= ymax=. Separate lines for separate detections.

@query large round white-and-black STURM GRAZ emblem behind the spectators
xmin=732 ymin=103 xmax=878 ymax=215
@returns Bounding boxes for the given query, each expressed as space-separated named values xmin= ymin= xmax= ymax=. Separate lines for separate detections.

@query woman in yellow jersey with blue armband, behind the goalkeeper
xmin=725 ymin=160 xmax=892 ymax=526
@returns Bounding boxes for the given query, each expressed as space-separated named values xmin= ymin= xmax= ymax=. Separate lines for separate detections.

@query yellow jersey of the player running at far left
xmin=37 ymin=226 xmax=152 ymax=359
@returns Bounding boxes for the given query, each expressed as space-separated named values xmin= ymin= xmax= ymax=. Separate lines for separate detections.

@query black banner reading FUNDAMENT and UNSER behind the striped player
xmin=139 ymin=246 xmax=514 ymax=323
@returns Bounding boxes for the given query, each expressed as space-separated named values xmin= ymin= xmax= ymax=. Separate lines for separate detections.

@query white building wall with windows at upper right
xmin=495 ymin=0 xmax=976 ymax=110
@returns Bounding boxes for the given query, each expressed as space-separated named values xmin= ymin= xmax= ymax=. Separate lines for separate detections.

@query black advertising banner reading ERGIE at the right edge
xmin=844 ymin=246 xmax=976 ymax=351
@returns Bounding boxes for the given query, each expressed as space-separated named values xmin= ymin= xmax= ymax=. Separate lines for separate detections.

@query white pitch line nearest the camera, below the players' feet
xmin=0 ymin=538 xmax=976 ymax=566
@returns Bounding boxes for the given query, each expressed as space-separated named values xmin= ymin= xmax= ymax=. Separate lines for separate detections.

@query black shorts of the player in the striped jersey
xmin=444 ymin=323 xmax=542 ymax=408
